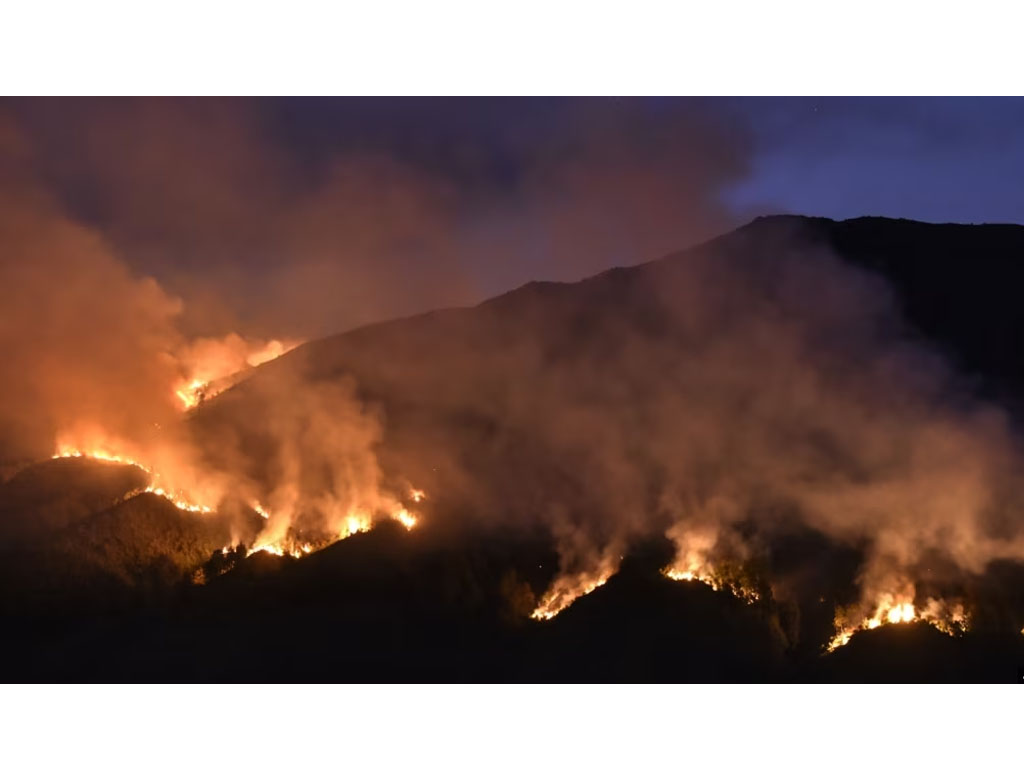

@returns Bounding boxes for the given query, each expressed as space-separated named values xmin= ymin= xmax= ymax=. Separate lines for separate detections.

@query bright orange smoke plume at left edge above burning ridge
xmin=0 ymin=114 xmax=180 ymax=458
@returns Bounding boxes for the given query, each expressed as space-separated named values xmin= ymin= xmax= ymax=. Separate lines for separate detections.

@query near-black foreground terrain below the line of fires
xmin=3 ymin=510 xmax=1024 ymax=682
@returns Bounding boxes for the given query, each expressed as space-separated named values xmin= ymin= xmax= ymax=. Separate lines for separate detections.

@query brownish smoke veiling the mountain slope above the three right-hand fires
xmin=197 ymin=225 xmax=1024 ymax=629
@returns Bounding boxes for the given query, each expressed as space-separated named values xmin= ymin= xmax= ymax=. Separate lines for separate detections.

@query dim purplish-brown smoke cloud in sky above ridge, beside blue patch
xmin=7 ymin=99 xmax=748 ymax=338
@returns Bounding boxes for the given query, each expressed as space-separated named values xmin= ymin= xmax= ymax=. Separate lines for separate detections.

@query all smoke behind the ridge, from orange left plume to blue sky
xmin=0 ymin=99 xmax=745 ymax=528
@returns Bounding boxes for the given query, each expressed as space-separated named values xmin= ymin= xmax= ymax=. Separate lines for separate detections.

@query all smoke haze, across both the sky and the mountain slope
xmin=0 ymin=100 xmax=1024 ymax=638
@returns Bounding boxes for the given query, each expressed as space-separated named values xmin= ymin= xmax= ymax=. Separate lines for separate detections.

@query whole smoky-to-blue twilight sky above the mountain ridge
xmin=0 ymin=98 xmax=1024 ymax=337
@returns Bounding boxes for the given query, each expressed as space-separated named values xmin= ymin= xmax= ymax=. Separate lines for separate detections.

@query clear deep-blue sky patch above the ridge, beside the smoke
xmin=726 ymin=97 xmax=1024 ymax=223
